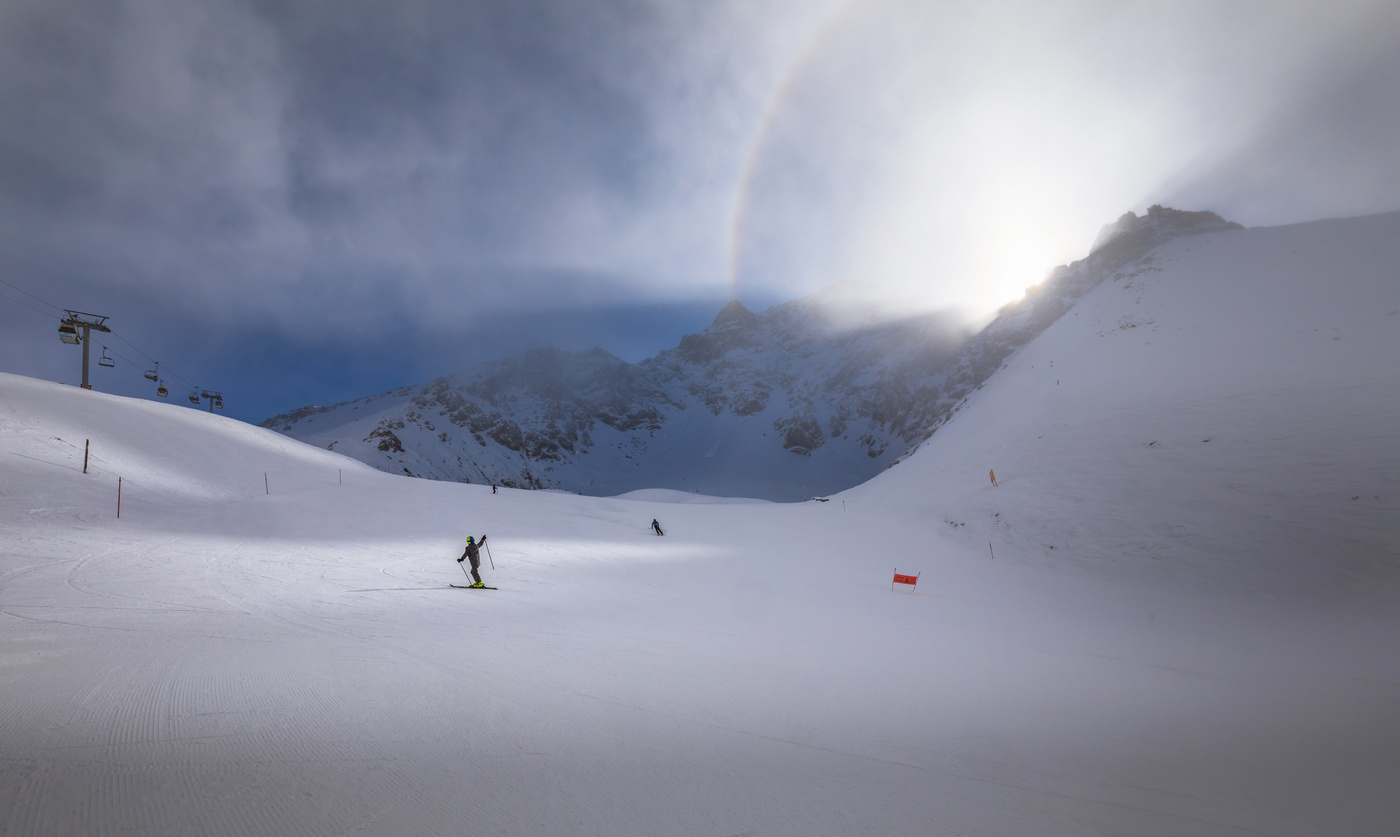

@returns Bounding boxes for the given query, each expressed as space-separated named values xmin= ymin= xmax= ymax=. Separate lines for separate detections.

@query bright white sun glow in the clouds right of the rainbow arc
xmin=734 ymin=0 xmax=1388 ymax=318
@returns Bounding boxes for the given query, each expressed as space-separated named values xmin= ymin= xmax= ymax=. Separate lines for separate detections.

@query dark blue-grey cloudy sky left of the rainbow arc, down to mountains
xmin=0 ymin=0 xmax=823 ymax=419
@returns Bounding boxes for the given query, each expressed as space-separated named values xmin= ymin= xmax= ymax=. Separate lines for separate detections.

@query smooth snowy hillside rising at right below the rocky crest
xmin=858 ymin=213 xmax=1400 ymax=600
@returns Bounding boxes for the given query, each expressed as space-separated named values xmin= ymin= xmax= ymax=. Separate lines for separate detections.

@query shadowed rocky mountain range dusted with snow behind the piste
xmin=262 ymin=206 xmax=1242 ymax=500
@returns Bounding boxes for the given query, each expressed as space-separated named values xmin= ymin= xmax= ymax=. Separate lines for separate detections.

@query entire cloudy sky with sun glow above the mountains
xmin=8 ymin=0 xmax=1400 ymax=420
